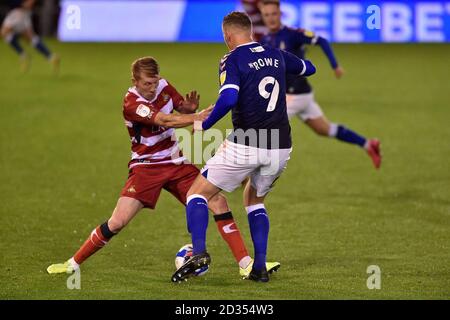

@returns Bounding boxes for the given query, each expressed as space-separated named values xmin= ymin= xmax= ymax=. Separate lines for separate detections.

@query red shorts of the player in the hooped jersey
xmin=120 ymin=163 xmax=200 ymax=209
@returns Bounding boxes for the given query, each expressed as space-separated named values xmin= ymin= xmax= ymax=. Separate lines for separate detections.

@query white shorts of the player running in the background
xmin=286 ymin=92 xmax=323 ymax=121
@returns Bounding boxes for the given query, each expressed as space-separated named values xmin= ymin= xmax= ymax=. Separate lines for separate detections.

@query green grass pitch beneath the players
xmin=0 ymin=41 xmax=450 ymax=299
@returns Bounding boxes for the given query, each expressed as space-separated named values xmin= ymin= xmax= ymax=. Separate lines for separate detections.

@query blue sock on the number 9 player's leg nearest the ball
xmin=186 ymin=194 xmax=209 ymax=254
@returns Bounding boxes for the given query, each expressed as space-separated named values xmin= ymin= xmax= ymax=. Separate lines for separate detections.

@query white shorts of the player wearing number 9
xmin=202 ymin=140 xmax=292 ymax=197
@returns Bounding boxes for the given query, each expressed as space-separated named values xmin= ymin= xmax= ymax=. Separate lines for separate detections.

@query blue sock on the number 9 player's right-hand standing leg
xmin=246 ymin=204 xmax=269 ymax=270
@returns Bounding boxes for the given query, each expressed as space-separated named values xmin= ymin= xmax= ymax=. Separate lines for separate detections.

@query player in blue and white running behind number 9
xmin=259 ymin=0 xmax=381 ymax=169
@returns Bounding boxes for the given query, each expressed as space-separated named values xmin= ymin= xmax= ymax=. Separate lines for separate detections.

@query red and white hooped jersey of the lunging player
xmin=123 ymin=79 xmax=186 ymax=169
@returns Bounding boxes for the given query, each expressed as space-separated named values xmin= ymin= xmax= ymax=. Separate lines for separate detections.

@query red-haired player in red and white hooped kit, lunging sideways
xmin=47 ymin=57 xmax=280 ymax=276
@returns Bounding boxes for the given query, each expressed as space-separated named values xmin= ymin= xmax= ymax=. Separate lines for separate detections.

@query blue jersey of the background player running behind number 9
xmin=261 ymin=26 xmax=318 ymax=94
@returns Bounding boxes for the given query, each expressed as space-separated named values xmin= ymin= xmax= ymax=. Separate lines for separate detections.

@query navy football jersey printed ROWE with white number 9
xmin=219 ymin=42 xmax=306 ymax=149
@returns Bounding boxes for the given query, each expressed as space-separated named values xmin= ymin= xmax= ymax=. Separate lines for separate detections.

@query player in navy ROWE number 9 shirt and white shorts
xmin=172 ymin=12 xmax=316 ymax=282
